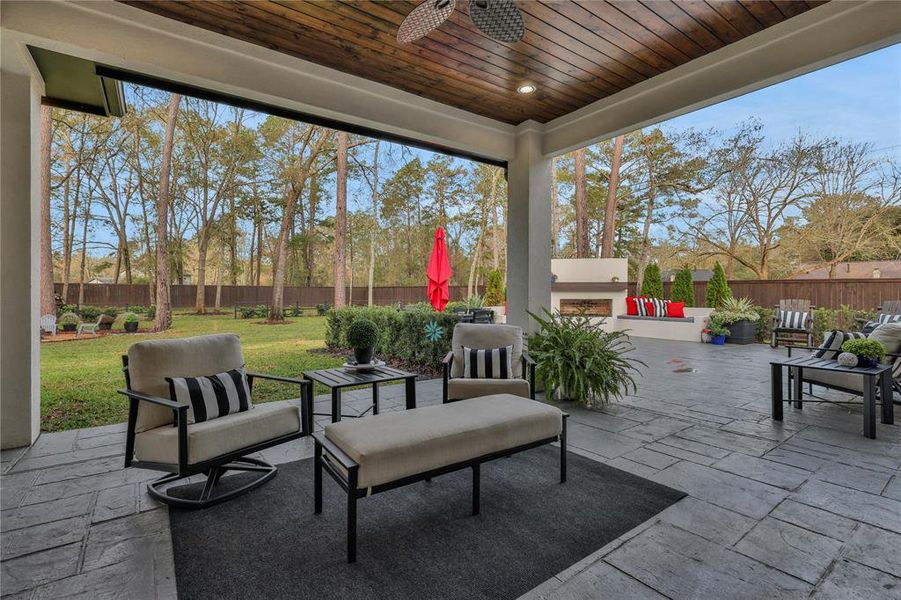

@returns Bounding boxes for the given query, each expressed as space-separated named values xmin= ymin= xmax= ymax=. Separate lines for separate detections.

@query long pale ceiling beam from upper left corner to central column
xmin=0 ymin=0 xmax=515 ymax=162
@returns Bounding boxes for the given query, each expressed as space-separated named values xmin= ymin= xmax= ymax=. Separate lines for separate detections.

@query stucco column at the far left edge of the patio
xmin=0 ymin=64 xmax=43 ymax=448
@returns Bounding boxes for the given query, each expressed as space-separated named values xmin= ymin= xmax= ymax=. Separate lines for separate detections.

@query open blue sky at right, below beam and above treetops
xmin=661 ymin=44 xmax=901 ymax=156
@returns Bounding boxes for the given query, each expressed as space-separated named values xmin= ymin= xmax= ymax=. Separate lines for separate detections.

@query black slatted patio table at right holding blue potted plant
xmin=770 ymin=356 xmax=894 ymax=438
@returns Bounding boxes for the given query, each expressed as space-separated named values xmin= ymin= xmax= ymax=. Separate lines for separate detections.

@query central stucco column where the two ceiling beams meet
xmin=507 ymin=121 xmax=551 ymax=330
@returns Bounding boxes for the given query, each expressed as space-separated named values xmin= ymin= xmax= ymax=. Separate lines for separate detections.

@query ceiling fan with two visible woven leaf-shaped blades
xmin=397 ymin=0 xmax=526 ymax=44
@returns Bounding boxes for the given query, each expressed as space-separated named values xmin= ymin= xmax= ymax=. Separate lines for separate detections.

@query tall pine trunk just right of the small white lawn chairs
xmin=156 ymin=94 xmax=181 ymax=331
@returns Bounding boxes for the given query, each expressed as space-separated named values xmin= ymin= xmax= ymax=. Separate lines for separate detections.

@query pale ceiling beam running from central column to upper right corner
xmin=542 ymin=0 xmax=901 ymax=155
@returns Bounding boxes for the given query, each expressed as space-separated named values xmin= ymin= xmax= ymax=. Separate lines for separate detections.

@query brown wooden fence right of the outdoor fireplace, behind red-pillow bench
xmin=629 ymin=279 xmax=901 ymax=310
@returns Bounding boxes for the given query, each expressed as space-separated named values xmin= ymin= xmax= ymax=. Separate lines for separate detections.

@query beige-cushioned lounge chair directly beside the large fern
xmin=442 ymin=323 xmax=535 ymax=402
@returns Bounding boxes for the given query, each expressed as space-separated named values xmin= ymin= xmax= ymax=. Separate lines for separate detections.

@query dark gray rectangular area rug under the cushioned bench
xmin=169 ymin=446 xmax=685 ymax=600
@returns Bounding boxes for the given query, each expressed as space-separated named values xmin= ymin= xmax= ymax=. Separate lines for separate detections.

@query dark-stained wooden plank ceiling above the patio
xmin=120 ymin=0 xmax=826 ymax=124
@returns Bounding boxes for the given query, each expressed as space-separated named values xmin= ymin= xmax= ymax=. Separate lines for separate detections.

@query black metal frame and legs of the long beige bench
xmin=313 ymin=413 xmax=569 ymax=563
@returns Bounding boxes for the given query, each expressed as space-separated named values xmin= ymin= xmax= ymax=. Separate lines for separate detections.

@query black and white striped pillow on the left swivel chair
xmin=166 ymin=367 xmax=252 ymax=423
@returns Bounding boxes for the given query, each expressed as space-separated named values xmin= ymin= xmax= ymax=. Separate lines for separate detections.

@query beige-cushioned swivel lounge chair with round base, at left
xmin=119 ymin=334 xmax=313 ymax=508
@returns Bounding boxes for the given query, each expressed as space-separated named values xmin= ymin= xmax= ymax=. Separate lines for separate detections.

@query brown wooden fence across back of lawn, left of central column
xmin=56 ymin=283 xmax=484 ymax=309
